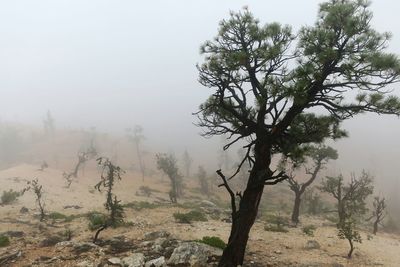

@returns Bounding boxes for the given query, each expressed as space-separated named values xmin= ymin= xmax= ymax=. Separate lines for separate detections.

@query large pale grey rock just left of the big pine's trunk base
xmin=167 ymin=242 xmax=222 ymax=267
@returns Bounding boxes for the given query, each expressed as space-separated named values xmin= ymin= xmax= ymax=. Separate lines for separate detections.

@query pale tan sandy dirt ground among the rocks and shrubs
xmin=0 ymin=164 xmax=400 ymax=266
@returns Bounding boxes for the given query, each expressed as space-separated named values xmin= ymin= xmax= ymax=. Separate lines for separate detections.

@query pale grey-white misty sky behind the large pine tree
xmin=0 ymin=0 xmax=400 ymax=193
